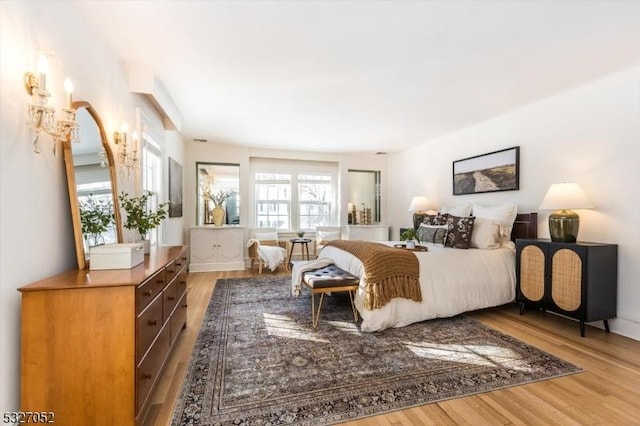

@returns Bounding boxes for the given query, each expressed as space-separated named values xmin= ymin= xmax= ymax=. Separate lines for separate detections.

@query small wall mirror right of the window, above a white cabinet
xmin=347 ymin=170 xmax=381 ymax=225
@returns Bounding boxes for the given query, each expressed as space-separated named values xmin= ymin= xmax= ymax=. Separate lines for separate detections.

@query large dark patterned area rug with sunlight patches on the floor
xmin=172 ymin=277 xmax=580 ymax=426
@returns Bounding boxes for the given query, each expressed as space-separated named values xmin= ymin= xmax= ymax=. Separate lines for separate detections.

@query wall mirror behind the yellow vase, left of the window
xmin=196 ymin=162 xmax=240 ymax=225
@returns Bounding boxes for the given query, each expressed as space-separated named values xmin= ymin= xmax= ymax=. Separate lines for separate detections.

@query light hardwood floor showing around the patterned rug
xmin=147 ymin=269 xmax=640 ymax=426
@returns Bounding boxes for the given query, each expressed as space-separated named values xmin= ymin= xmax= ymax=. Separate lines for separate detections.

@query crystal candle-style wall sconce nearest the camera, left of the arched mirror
xmin=24 ymin=53 xmax=80 ymax=156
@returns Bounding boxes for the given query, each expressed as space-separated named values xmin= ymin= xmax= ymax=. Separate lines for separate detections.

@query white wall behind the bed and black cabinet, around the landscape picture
xmin=388 ymin=66 xmax=640 ymax=339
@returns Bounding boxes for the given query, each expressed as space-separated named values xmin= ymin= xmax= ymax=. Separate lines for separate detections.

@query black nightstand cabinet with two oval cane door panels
xmin=516 ymin=239 xmax=618 ymax=337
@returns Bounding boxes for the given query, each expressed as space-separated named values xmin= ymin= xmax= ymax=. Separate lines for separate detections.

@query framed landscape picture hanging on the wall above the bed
xmin=453 ymin=146 xmax=520 ymax=195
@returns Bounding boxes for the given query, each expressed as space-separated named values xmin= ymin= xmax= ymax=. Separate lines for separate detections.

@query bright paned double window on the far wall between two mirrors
xmin=252 ymin=159 xmax=338 ymax=231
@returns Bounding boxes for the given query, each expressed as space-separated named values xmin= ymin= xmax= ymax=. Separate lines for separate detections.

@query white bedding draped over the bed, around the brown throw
xmin=318 ymin=242 xmax=516 ymax=331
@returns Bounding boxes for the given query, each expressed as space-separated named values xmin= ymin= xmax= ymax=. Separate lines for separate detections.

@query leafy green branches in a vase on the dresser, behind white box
xmin=118 ymin=191 xmax=169 ymax=254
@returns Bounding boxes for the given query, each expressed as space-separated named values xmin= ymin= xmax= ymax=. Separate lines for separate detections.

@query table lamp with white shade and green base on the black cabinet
xmin=540 ymin=182 xmax=593 ymax=243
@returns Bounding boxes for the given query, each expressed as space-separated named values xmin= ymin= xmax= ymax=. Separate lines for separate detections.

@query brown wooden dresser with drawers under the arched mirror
xmin=18 ymin=246 xmax=189 ymax=426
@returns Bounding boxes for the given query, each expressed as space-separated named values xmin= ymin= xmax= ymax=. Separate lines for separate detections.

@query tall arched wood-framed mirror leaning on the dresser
xmin=63 ymin=101 xmax=122 ymax=269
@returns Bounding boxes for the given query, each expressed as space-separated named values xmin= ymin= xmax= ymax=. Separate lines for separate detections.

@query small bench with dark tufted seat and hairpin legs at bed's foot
xmin=302 ymin=265 xmax=360 ymax=329
